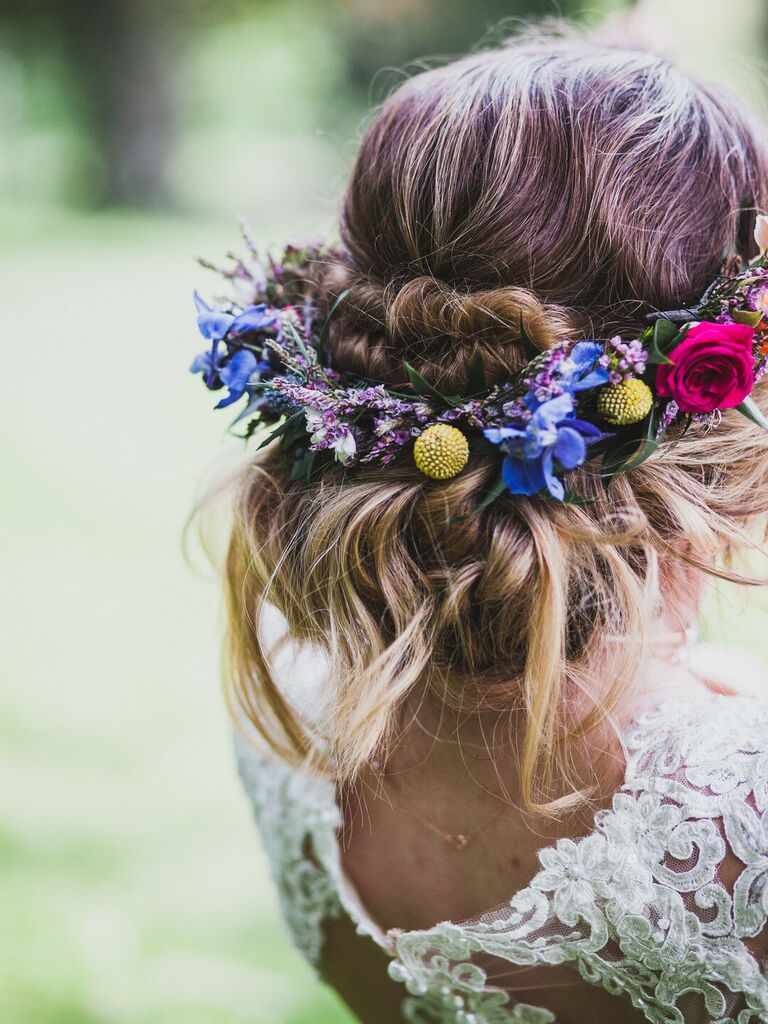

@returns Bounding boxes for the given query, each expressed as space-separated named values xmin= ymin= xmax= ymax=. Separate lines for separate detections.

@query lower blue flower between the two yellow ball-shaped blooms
xmin=483 ymin=392 xmax=605 ymax=501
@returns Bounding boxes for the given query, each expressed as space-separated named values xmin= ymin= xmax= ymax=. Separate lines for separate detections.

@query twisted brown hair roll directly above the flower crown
xmin=324 ymin=264 xmax=577 ymax=390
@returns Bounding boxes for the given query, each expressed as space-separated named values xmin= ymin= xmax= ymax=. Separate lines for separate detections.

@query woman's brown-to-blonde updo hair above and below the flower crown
xmin=227 ymin=25 xmax=768 ymax=805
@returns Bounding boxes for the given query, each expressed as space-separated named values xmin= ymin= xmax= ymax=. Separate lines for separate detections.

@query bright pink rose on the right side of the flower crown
xmin=656 ymin=321 xmax=755 ymax=413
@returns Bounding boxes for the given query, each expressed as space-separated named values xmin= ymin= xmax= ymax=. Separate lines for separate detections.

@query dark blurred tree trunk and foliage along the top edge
xmin=0 ymin=0 xmax=621 ymax=206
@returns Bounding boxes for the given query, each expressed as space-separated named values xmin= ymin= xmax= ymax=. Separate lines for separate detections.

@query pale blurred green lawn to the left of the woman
xmin=0 ymin=210 xmax=358 ymax=1024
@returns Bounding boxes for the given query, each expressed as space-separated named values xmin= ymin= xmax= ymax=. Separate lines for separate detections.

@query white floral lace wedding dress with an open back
xmin=238 ymin=694 xmax=768 ymax=1024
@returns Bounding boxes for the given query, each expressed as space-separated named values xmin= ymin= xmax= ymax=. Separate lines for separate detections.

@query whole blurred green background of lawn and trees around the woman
xmin=0 ymin=0 xmax=768 ymax=1024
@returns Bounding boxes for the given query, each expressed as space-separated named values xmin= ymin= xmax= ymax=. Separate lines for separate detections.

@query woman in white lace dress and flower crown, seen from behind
xmin=193 ymin=25 xmax=768 ymax=1024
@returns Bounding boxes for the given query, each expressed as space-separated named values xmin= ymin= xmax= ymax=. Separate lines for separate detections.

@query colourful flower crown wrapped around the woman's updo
xmin=190 ymin=216 xmax=768 ymax=506
